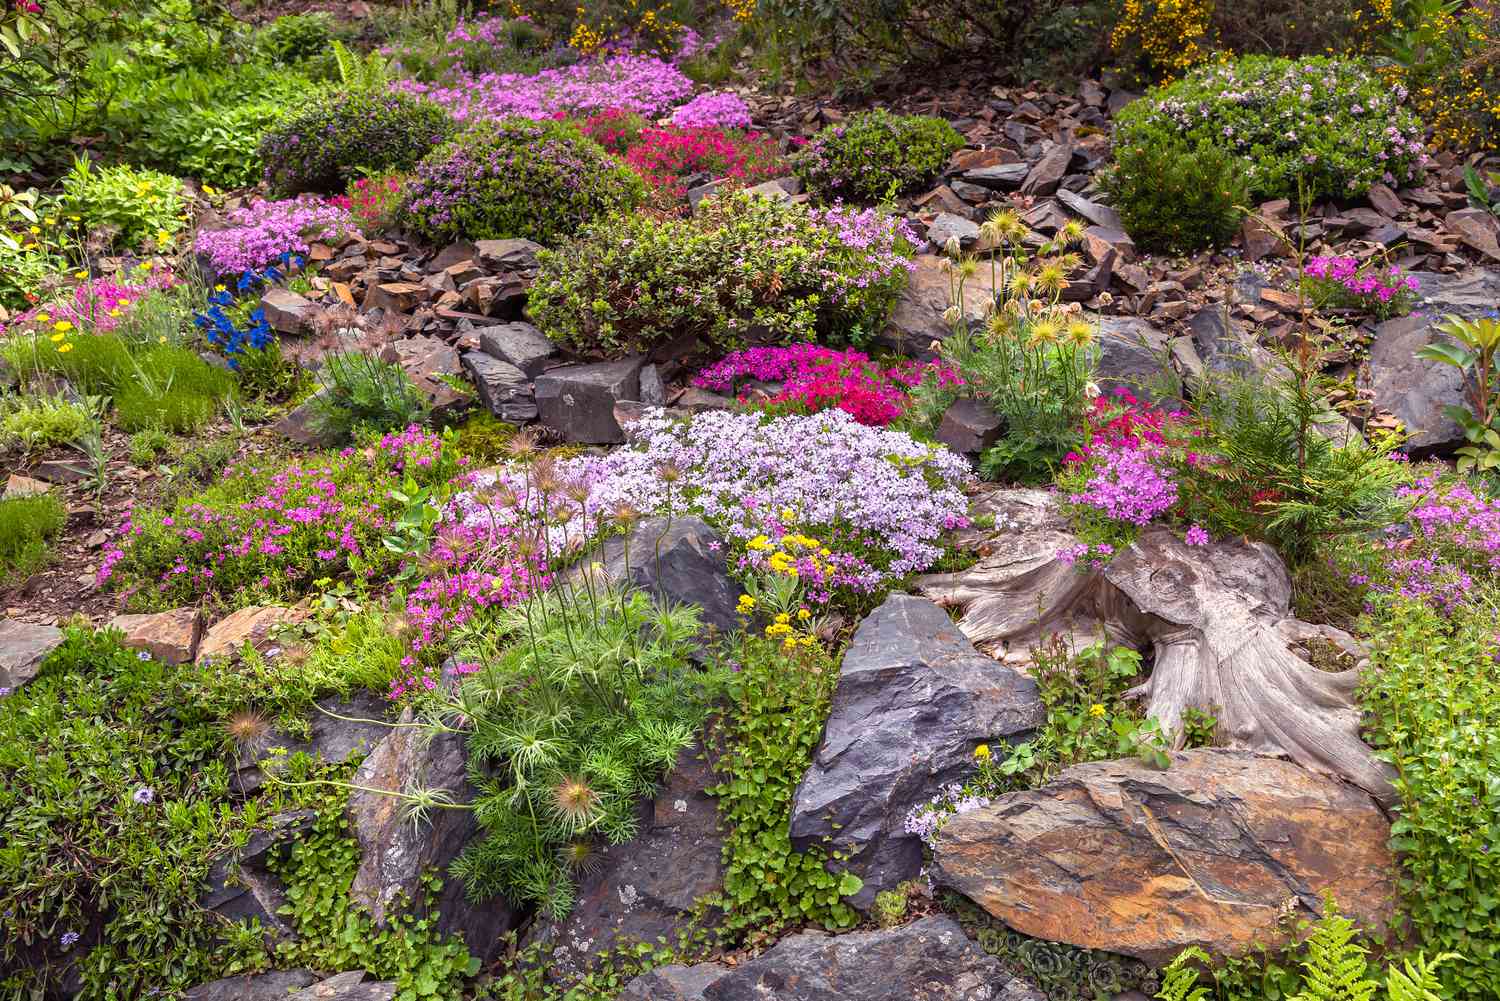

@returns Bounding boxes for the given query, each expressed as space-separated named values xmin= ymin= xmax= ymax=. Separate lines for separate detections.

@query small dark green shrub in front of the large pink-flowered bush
xmin=1101 ymin=137 xmax=1250 ymax=254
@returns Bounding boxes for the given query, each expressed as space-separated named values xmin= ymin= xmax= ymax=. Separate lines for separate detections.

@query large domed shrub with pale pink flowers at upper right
xmin=1115 ymin=56 xmax=1427 ymax=201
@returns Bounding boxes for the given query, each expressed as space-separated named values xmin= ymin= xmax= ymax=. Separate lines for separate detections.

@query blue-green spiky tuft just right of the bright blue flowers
xmin=308 ymin=351 xmax=432 ymax=441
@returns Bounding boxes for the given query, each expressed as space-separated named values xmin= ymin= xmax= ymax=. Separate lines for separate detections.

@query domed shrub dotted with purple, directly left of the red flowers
xmin=399 ymin=119 xmax=647 ymax=243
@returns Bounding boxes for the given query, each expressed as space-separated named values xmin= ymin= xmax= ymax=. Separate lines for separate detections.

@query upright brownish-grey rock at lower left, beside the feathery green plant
xmin=348 ymin=711 xmax=518 ymax=963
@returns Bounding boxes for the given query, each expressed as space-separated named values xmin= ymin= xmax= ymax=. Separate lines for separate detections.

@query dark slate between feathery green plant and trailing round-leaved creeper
xmin=530 ymin=746 xmax=723 ymax=978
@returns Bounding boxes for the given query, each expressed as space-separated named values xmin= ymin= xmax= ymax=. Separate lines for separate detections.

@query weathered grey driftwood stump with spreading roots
xmin=917 ymin=491 xmax=1395 ymax=804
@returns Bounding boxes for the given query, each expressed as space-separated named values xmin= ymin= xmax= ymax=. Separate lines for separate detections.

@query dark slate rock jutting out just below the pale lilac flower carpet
xmin=599 ymin=516 xmax=741 ymax=633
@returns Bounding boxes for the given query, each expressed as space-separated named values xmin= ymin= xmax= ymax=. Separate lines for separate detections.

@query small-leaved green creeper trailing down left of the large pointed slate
xmin=707 ymin=636 xmax=860 ymax=933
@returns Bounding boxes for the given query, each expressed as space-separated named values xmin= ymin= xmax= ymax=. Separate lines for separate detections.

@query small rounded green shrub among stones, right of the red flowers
xmin=792 ymin=110 xmax=963 ymax=203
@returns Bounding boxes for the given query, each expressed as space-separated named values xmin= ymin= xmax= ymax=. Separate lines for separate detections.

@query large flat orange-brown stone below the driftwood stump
xmin=935 ymin=749 xmax=1398 ymax=963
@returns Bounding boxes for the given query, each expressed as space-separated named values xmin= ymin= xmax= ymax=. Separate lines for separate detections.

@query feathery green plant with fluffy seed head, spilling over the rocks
xmin=452 ymin=579 xmax=723 ymax=917
